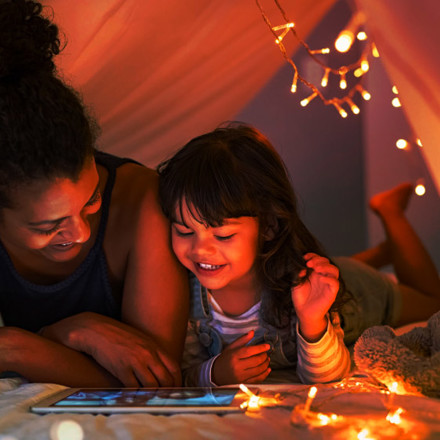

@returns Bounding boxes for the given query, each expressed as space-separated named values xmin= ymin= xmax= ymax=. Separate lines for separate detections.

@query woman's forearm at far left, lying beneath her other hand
xmin=0 ymin=327 xmax=121 ymax=387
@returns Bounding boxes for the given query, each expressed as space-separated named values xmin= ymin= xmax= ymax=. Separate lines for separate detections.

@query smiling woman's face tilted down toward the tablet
xmin=0 ymin=161 xmax=101 ymax=262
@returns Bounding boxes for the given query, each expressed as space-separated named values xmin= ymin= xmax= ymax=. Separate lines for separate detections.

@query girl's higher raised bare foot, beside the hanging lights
xmin=370 ymin=182 xmax=414 ymax=216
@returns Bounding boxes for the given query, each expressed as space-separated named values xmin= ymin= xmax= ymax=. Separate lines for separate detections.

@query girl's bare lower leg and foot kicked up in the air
xmin=370 ymin=183 xmax=440 ymax=298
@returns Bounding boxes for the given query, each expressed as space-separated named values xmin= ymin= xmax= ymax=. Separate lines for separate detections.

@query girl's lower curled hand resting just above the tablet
xmin=212 ymin=330 xmax=271 ymax=385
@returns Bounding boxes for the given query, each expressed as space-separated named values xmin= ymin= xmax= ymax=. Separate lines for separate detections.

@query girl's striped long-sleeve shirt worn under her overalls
xmin=182 ymin=294 xmax=351 ymax=386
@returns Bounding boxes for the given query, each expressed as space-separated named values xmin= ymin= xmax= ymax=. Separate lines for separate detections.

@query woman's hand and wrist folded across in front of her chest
xmin=40 ymin=312 xmax=181 ymax=388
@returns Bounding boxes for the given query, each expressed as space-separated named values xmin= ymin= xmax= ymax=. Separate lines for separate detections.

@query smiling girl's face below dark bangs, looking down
xmin=172 ymin=203 xmax=259 ymax=293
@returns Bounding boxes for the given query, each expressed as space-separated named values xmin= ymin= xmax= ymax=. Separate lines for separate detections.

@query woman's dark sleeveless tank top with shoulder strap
xmin=0 ymin=152 xmax=138 ymax=332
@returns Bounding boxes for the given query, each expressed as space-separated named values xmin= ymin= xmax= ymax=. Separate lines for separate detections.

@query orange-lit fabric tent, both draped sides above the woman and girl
xmin=44 ymin=0 xmax=440 ymax=192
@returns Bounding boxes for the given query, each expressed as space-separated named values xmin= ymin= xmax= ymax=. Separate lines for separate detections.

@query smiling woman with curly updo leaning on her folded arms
xmin=0 ymin=0 xmax=188 ymax=386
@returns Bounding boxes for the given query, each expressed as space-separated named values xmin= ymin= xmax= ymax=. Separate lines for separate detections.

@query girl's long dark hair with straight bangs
xmin=158 ymin=123 xmax=343 ymax=327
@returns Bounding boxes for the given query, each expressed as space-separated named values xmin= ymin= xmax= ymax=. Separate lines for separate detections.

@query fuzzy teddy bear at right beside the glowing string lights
xmin=354 ymin=312 xmax=440 ymax=398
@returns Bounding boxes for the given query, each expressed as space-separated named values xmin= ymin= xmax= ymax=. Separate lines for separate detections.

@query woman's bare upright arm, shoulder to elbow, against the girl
xmin=122 ymin=170 xmax=189 ymax=385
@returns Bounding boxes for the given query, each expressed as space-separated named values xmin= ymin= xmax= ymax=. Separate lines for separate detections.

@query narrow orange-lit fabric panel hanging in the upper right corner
xmin=357 ymin=0 xmax=440 ymax=193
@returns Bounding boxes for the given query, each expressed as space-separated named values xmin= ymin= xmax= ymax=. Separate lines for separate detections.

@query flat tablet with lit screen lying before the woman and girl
xmin=30 ymin=388 xmax=249 ymax=414
